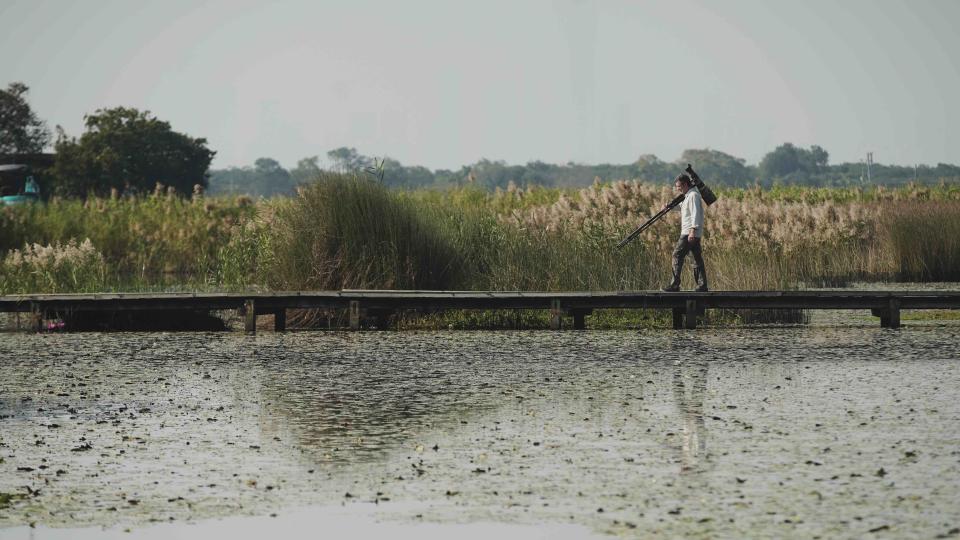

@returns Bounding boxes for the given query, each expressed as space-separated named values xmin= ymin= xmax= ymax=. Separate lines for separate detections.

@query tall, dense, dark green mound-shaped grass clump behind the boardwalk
xmin=266 ymin=174 xmax=465 ymax=290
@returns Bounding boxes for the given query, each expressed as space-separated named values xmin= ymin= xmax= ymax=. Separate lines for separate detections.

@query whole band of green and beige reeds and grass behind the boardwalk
xmin=0 ymin=174 xmax=960 ymax=328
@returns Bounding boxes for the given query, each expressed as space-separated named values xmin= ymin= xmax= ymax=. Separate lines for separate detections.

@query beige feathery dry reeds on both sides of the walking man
xmin=496 ymin=181 xmax=960 ymax=290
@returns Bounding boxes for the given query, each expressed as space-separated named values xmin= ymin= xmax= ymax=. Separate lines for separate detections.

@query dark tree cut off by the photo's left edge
xmin=0 ymin=82 xmax=50 ymax=154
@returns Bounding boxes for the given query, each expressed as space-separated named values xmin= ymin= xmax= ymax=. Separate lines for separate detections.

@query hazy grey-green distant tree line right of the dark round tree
xmin=210 ymin=143 xmax=960 ymax=196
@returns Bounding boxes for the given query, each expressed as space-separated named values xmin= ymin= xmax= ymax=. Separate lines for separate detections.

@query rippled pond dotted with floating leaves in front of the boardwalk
xmin=0 ymin=320 xmax=960 ymax=538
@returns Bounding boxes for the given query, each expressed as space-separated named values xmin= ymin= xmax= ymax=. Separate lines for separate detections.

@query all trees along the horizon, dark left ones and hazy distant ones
xmin=0 ymin=83 xmax=960 ymax=197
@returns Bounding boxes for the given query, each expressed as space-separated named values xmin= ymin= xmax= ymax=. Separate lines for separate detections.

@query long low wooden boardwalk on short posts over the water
xmin=0 ymin=290 xmax=960 ymax=332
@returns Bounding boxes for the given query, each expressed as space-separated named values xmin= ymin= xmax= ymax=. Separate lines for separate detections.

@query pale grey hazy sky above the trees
xmin=0 ymin=0 xmax=960 ymax=169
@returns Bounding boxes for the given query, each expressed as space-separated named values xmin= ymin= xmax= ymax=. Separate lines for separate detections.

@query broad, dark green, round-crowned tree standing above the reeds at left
xmin=53 ymin=107 xmax=216 ymax=197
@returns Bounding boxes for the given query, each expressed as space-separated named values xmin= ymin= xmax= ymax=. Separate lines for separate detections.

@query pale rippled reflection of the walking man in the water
xmin=673 ymin=360 xmax=707 ymax=473
